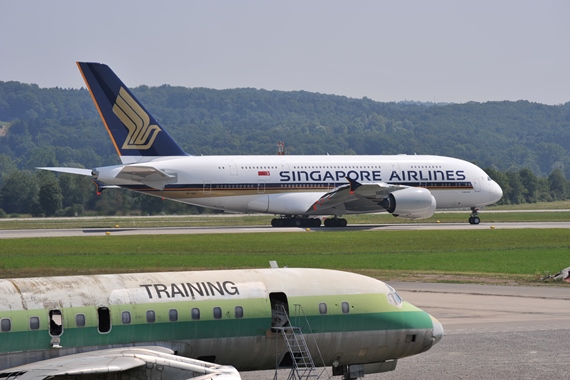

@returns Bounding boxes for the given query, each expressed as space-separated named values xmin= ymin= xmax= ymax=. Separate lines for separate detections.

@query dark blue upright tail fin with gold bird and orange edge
xmin=77 ymin=62 xmax=188 ymax=164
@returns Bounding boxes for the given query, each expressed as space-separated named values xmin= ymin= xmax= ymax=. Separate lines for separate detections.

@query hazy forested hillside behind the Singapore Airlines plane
xmin=0 ymin=81 xmax=570 ymax=217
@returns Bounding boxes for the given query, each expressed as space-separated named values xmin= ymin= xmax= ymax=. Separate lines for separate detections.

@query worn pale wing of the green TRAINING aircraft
xmin=7 ymin=346 xmax=241 ymax=380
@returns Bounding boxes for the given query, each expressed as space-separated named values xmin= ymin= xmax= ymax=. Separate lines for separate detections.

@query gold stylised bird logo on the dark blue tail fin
xmin=113 ymin=87 xmax=161 ymax=150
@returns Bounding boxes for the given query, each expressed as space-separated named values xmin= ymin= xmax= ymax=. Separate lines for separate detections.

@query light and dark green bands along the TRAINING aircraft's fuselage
xmin=0 ymin=294 xmax=432 ymax=352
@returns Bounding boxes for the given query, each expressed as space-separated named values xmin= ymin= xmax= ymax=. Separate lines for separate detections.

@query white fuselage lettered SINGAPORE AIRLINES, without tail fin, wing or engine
xmin=96 ymin=155 xmax=502 ymax=215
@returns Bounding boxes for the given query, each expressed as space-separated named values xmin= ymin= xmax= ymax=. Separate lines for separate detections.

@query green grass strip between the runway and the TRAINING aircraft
xmin=0 ymin=229 xmax=570 ymax=284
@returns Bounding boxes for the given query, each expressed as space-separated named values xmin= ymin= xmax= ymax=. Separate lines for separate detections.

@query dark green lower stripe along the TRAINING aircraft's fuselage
xmin=0 ymin=311 xmax=432 ymax=352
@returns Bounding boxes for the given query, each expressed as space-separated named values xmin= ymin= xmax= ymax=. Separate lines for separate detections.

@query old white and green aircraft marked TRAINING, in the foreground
xmin=0 ymin=268 xmax=443 ymax=380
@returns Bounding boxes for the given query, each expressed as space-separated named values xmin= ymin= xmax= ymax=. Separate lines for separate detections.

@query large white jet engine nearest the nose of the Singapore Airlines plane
xmin=380 ymin=187 xmax=436 ymax=219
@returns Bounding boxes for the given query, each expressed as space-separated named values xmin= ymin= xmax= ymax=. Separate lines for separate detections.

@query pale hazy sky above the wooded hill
xmin=0 ymin=0 xmax=570 ymax=104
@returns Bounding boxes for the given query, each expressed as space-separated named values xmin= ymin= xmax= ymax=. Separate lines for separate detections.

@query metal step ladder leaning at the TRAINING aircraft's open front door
xmin=273 ymin=304 xmax=326 ymax=380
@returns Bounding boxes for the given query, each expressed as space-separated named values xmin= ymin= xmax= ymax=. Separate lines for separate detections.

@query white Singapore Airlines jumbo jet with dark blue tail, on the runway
xmin=39 ymin=62 xmax=503 ymax=227
